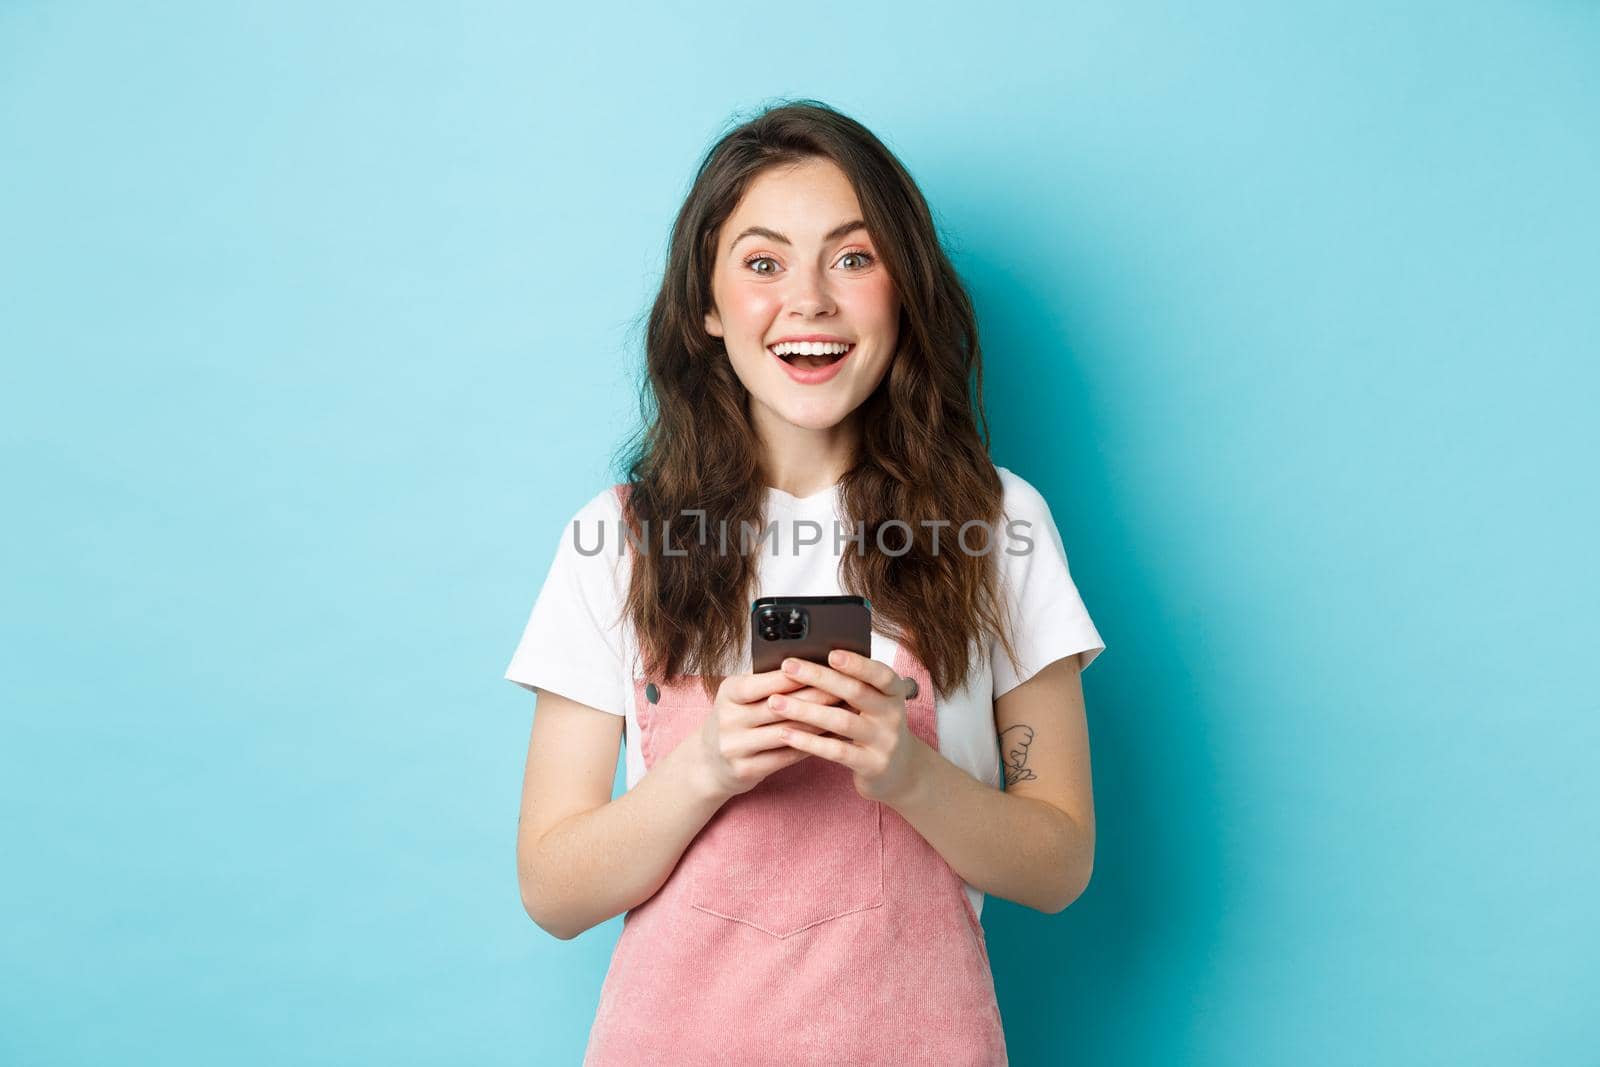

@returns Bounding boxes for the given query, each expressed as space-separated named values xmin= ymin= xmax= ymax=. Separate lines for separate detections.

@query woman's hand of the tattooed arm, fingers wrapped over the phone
xmin=766 ymin=649 xmax=928 ymax=806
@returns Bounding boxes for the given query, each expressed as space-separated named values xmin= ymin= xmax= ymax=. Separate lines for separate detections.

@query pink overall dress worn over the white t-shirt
xmin=584 ymin=489 xmax=1006 ymax=1067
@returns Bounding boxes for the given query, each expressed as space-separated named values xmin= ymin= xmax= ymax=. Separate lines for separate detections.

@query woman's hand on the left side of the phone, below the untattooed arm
xmin=699 ymin=670 xmax=838 ymax=798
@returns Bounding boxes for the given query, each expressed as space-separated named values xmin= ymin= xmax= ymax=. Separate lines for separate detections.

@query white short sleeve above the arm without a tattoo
xmin=506 ymin=490 xmax=626 ymax=715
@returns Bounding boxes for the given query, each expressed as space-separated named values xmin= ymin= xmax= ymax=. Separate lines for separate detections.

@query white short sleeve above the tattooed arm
xmin=990 ymin=467 xmax=1106 ymax=699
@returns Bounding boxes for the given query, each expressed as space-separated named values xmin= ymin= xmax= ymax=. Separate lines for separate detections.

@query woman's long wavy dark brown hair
xmin=619 ymin=99 xmax=1016 ymax=697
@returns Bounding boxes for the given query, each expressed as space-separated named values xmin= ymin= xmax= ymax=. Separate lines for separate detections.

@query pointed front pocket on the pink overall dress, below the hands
xmin=690 ymin=755 xmax=883 ymax=937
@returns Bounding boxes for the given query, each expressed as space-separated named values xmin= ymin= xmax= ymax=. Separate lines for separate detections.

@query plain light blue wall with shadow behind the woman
xmin=0 ymin=0 xmax=1600 ymax=1064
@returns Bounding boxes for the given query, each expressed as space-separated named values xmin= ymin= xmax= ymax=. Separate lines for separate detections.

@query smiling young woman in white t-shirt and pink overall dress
xmin=506 ymin=101 xmax=1104 ymax=1065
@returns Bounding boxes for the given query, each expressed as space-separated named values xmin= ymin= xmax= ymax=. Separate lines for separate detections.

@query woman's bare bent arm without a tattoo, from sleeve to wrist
xmin=517 ymin=689 xmax=726 ymax=941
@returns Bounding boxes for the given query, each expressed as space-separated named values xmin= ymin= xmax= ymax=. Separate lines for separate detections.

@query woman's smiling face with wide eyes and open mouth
xmin=706 ymin=158 xmax=899 ymax=434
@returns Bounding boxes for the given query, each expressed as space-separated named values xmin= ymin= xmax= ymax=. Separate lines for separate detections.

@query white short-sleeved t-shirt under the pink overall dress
xmin=506 ymin=466 xmax=1106 ymax=912
